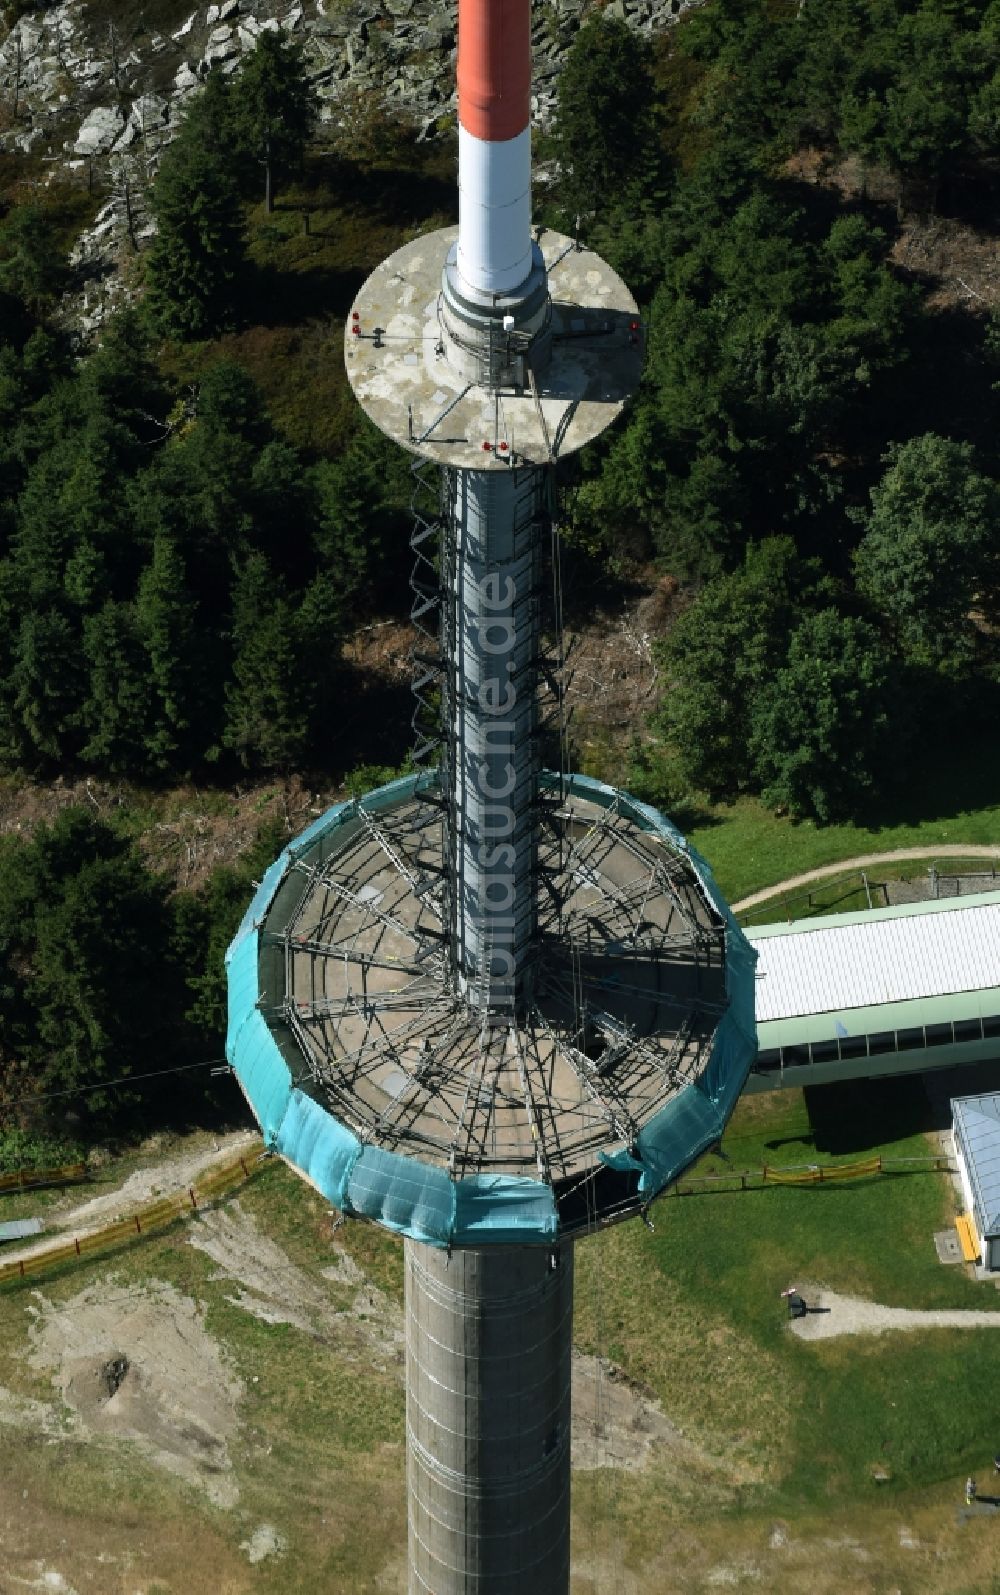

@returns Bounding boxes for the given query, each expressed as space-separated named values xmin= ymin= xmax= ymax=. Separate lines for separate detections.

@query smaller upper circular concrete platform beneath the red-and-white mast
xmin=344 ymin=226 xmax=643 ymax=471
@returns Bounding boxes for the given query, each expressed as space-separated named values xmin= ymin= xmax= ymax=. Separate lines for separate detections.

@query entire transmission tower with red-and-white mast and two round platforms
xmin=228 ymin=0 xmax=756 ymax=1595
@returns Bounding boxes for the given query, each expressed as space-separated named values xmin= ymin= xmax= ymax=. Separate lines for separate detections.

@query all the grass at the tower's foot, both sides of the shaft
xmin=0 ymin=1103 xmax=1000 ymax=1595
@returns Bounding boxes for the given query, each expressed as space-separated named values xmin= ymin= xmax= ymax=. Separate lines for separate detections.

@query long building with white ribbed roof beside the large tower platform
xmin=746 ymin=892 xmax=1000 ymax=1091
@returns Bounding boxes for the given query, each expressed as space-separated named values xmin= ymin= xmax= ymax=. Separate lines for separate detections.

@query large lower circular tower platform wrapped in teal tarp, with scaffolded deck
xmin=226 ymin=777 xmax=756 ymax=1246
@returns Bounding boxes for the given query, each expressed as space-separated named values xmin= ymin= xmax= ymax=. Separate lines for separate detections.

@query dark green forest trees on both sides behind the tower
xmin=0 ymin=0 xmax=1000 ymax=1161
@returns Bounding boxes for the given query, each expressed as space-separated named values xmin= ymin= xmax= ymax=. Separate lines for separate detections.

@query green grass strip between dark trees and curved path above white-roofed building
xmin=692 ymin=746 xmax=1000 ymax=901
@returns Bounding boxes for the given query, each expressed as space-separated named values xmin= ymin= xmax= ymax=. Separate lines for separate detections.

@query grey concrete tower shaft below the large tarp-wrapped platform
xmin=405 ymin=1241 xmax=573 ymax=1595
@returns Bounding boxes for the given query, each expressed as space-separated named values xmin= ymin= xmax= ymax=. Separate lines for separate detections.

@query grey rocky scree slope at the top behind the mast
xmin=0 ymin=0 xmax=699 ymax=333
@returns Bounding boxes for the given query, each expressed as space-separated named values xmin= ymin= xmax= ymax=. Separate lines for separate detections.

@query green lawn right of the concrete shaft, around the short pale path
xmin=577 ymin=1080 xmax=1000 ymax=1515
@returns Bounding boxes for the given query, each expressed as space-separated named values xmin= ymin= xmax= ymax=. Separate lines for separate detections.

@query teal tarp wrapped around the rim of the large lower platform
xmin=226 ymin=775 xmax=756 ymax=1246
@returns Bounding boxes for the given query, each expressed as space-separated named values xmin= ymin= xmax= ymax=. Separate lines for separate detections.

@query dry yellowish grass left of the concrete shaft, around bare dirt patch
xmin=0 ymin=1164 xmax=405 ymax=1595
